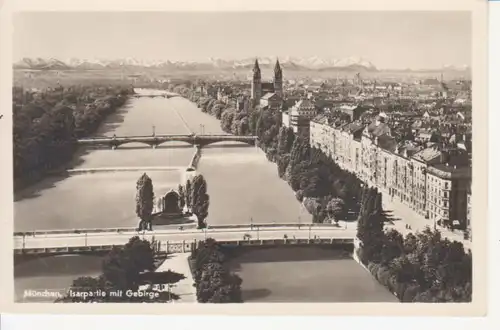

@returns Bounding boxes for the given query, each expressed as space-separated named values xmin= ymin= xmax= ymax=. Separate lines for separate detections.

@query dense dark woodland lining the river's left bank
xmin=12 ymin=85 xmax=133 ymax=188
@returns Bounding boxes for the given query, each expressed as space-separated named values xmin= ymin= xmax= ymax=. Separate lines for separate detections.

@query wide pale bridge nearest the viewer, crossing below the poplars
xmin=14 ymin=224 xmax=356 ymax=257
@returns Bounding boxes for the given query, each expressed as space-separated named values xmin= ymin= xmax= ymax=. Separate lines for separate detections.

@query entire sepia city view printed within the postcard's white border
xmin=2 ymin=1 xmax=484 ymax=308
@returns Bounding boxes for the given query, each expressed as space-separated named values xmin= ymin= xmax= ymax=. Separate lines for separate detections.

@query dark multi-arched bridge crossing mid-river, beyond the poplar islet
xmin=78 ymin=134 xmax=257 ymax=149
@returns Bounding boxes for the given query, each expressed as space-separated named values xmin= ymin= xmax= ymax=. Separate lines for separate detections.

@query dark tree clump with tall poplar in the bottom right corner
xmin=355 ymin=188 xmax=472 ymax=302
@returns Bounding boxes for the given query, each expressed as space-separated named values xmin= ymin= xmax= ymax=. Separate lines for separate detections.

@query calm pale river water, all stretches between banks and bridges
xmin=14 ymin=90 xmax=395 ymax=302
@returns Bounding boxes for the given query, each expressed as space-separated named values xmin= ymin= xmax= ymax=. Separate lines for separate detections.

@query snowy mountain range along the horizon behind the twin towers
xmin=13 ymin=56 xmax=469 ymax=72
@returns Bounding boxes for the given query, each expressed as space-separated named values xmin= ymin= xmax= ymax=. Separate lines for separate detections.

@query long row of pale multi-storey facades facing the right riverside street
xmin=310 ymin=115 xmax=471 ymax=229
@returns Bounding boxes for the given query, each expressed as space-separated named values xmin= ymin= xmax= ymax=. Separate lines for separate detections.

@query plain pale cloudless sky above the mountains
xmin=13 ymin=11 xmax=472 ymax=69
